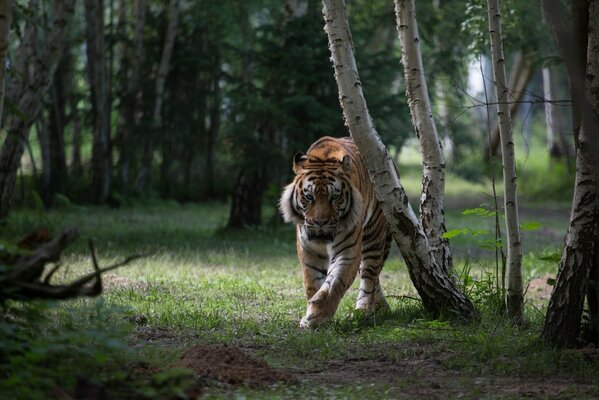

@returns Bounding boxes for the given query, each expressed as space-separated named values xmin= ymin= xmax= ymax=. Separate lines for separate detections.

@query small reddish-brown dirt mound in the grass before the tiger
xmin=173 ymin=345 xmax=296 ymax=388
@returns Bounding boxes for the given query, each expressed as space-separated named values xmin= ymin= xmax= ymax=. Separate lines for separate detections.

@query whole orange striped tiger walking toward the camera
xmin=279 ymin=136 xmax=391 ymax=329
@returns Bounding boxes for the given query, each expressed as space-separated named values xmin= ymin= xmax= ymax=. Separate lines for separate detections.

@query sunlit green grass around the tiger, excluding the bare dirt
xmin=2 ymin=200 xmax=597 ymax=399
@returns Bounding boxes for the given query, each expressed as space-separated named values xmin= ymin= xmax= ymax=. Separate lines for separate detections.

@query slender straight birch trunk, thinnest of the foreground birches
xmin=487 ymin=0 xmax=524 ymax=322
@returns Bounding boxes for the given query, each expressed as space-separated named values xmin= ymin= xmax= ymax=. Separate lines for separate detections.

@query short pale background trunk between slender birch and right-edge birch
xmin=543 ymin=66 xmax=567 ymax=159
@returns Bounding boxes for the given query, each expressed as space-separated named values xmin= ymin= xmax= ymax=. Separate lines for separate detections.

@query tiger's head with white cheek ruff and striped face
xmin=279 ymin=153 xmax=362 ymax=242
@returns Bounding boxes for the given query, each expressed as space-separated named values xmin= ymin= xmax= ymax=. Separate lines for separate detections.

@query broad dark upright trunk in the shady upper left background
xmin=85 ymin=0 xmax=112 ymax=204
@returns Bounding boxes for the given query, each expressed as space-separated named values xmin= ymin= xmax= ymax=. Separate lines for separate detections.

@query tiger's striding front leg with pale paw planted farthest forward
xmin=300 ymin=234 xmax=360 ymax=329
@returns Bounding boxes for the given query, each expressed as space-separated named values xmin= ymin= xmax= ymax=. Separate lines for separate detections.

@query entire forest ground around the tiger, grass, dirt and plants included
xmin=0 ymin=199 xmax=599 ymax=399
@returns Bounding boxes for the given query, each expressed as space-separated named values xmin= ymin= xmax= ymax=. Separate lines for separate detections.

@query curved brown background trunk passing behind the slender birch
xmin=485 ymin=51 xmax=533 ymax=155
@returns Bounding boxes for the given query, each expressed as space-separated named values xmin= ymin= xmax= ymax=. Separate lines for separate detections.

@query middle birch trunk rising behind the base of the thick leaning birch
xmin=395 ymin=0 xmax=453 ymax=274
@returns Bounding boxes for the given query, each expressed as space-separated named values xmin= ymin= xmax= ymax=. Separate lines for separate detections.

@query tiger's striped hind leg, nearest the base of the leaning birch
xmin=356 ymin=213 xmax=391 ymax=313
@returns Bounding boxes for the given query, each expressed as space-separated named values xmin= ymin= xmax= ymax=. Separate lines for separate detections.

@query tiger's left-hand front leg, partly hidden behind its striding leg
xmin=297 ymin=233 xmax=329 ymax=300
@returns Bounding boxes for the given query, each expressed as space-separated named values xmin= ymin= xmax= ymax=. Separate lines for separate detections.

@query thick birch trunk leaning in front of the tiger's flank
xmin=323 ymin=0 xmax=476 ymax=320
